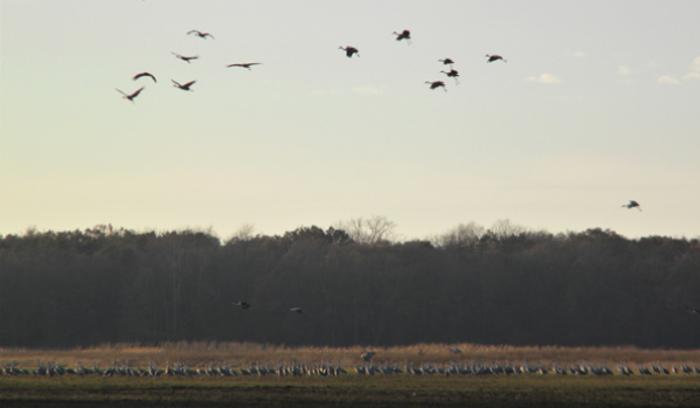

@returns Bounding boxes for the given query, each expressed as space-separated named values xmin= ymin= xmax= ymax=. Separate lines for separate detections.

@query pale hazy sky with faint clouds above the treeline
xmin=0 ymin=0 xmax=700 ymax=239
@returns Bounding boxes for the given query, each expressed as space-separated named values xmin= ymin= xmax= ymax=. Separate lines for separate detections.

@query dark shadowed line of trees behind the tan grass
xmin=0 ymin=219 xmax=700 ymax=347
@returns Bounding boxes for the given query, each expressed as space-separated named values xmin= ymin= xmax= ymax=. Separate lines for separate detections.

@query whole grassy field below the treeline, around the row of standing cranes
xmin=0 ymin=343 xmax=700 ymax=407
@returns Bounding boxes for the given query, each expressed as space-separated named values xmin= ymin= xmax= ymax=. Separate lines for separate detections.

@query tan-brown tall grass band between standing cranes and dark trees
xmin=0 ymin=342 xmax=700 ymax=367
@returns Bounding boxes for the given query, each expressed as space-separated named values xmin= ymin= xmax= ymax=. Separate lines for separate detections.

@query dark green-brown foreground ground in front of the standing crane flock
xmin=0 ymin=376 xmax=700 ymax=407
